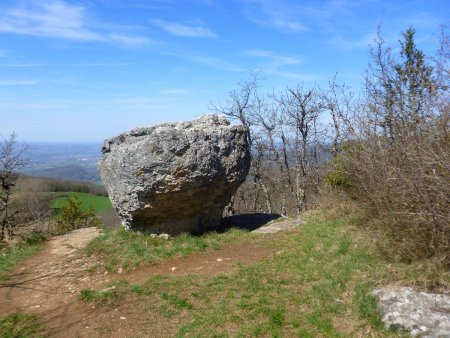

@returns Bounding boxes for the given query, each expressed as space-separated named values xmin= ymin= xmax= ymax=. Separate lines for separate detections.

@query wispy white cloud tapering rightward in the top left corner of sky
xmin=0 ymin=0 xmax=150 ymax=45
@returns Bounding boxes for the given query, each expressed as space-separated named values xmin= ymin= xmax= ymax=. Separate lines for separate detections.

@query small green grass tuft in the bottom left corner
xmin=0 ymin=312 xmax=44 ymax=338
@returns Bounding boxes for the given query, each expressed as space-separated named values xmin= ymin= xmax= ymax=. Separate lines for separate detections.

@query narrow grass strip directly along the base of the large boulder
xmin=85 ymin=229 xmax=247 ymax=271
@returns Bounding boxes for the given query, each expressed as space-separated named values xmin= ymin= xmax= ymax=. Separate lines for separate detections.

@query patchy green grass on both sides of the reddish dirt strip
xmin=78 ymin=215 xmax=450 ymax=337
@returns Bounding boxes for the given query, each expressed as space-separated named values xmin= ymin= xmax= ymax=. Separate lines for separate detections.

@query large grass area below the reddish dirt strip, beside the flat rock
xmin=148 ymin=215 xmax=390 ymax=337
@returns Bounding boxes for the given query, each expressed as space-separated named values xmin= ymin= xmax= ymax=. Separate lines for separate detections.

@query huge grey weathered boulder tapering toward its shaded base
xmin=100 ymin=115 xmax=250 ymax=235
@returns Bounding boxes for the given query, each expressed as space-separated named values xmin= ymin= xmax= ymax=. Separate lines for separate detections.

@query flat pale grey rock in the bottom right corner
xmin=373 ymin=287 xmax=450 ymax=338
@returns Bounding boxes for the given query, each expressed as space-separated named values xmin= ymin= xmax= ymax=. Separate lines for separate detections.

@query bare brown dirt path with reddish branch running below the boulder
xmin=0 ymin=221 xmax=302 ymax=337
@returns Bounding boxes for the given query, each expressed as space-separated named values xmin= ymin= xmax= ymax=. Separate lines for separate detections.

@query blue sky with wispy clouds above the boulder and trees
xmin=0 ymin=0 xmax=450 ymax=143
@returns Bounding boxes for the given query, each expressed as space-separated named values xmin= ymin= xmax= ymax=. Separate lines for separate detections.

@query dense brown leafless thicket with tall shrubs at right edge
xmin=342 ymin=29 xmax=450 ymax=266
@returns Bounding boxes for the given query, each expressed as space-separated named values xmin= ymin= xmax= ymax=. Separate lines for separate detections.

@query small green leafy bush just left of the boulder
xmin=57 ymin=195 xmax=100 ymax=233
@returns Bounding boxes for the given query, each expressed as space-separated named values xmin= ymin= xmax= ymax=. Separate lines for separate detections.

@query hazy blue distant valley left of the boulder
xmin=20 ymin=143 xmax=102 ymax=183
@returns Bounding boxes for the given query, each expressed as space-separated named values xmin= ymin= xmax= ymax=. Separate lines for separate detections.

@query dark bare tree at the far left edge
xmin=0 ymin=133 xmax=27 ymax=242
